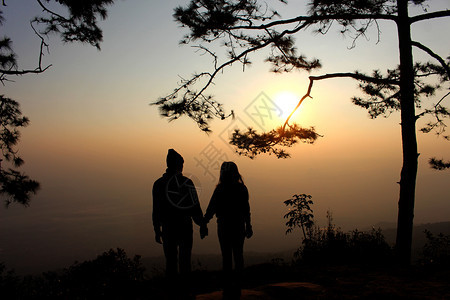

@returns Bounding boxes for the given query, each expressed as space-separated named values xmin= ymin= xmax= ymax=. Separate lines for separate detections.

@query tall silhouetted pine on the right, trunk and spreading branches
xmin=155 ymin=0 xmax=450 ymax=264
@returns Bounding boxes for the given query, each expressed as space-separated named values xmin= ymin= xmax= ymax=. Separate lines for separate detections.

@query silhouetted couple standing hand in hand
xmin=152 ymin=149 xmax=253 ymax=298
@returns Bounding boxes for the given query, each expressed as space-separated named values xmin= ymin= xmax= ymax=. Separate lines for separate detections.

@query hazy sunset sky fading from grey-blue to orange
xmin=0 ymin=0 xmax=450 ymax=272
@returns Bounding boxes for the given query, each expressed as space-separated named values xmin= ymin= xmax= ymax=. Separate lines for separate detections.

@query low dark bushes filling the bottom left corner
xmin=0 ymin=248 xmax=144 ymax=299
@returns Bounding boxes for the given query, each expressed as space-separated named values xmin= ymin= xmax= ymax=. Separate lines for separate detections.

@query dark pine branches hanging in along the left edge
xmin=0 ymin=0 xmax=114 ymax=206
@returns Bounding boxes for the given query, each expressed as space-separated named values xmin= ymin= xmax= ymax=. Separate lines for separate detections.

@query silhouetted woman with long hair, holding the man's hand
xmin=205 ymin=161 xmax=253 ymax=295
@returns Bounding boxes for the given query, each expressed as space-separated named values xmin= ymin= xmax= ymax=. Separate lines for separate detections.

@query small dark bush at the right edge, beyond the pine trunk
xmin=420 ymin=230 xmax=450 ymax=267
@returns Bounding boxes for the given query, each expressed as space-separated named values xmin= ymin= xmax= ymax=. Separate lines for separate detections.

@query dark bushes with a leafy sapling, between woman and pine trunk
xmin=284 ymin=194 xmax=393 ymax=265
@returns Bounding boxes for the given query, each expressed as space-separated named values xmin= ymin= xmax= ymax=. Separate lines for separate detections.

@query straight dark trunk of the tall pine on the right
xmin=396 ymin=0 xmax=418 ymax=265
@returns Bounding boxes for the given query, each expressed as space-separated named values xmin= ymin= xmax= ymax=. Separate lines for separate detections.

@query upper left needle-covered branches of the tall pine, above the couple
xmin=153 ymin=0 xmax=321 ymax=131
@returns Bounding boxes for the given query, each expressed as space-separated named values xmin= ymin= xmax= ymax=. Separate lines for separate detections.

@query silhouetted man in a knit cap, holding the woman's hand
xmin=152 ymin=149 xmax=207 ymax=277
